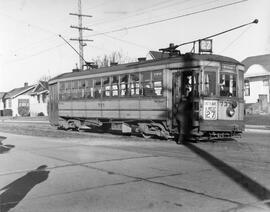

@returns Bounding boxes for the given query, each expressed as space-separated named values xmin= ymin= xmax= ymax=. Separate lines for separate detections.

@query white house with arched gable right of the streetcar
xmin=242 ymin=54 xmax=270 ymax=113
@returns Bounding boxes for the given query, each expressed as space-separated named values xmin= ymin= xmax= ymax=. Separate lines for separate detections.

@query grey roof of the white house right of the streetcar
xmin=242 ymin=54 xmax=270 ymax=70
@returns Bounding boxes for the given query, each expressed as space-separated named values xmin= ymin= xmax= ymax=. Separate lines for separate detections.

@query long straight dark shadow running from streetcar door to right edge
xmin=184 ymin=143 xmax=270 ymax=206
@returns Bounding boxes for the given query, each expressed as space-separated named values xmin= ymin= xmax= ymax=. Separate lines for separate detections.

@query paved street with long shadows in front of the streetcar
xmin=0 ymin=132 xmax=270 ymax=212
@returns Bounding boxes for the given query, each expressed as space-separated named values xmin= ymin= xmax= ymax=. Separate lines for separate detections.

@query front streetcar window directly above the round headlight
xmin=220 ymin=73 xmax=236 ymax=96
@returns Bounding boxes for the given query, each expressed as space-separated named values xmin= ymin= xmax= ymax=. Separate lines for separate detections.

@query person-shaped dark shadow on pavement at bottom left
xmin=0 ymin=165 xmax=49 ymax=212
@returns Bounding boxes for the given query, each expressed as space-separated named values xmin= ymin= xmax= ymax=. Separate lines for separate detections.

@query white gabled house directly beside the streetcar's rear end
xmin=30 ymin=81 xmax=49 ymax=116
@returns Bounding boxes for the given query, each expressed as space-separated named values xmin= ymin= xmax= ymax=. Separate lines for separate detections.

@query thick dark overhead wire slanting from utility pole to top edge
xmin=86 ymin=0 xmax=248 ymax=37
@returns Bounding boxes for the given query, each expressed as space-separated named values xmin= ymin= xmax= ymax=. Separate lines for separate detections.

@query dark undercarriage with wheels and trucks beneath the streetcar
xmin=58 ymin=117 xmax=241 ymax=142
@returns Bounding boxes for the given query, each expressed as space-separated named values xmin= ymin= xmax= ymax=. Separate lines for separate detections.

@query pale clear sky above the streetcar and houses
xmin=0 ymin=0 xmax=270 ymax=92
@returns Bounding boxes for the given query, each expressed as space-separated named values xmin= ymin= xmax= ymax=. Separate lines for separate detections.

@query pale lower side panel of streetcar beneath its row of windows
xmin=59 ymin=97 xmax=167 ymax=120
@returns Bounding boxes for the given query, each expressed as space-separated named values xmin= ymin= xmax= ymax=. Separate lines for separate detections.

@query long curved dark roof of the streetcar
xmin=50 ymin=53 xmax=243 ymax=81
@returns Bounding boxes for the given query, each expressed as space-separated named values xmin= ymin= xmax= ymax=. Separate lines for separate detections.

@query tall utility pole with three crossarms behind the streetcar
xmin=69 ymin=0 xmax=93 ymax=70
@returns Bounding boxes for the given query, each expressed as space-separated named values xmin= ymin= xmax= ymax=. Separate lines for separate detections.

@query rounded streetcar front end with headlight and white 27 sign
xmin=199 ymin=62 xmax=245 ymax=138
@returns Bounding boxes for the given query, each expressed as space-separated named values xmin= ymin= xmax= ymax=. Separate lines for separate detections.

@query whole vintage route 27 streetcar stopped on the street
xmin=48 ymin=42 xmax=244 ymax=139
